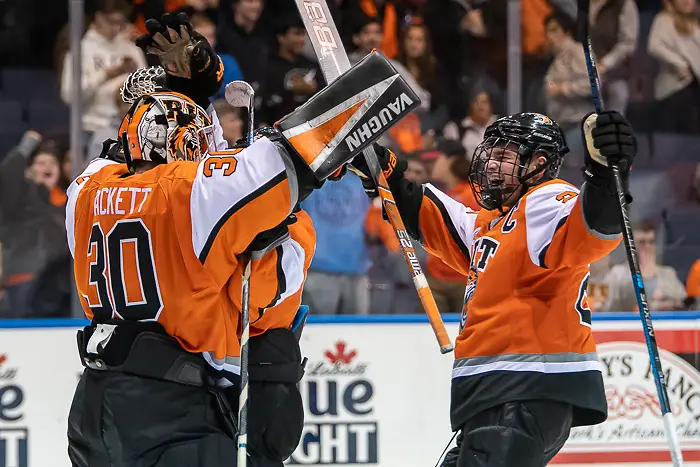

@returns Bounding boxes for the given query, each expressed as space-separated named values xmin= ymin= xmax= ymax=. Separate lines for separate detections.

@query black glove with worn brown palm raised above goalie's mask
xmin=136 ymin=13 xmax=224 ymax=109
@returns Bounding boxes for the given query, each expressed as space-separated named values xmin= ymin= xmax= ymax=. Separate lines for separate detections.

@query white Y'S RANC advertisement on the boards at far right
xmin=567 ymin=342 xmax=700 ymax=450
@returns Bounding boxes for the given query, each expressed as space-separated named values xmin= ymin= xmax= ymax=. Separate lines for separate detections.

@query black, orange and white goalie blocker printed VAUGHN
xmin=275 ymin=52 xmax=420 ymax=180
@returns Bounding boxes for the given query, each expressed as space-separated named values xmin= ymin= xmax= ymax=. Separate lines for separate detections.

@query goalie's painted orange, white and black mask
xmin=119 ymin=92 xmax=215 ymax=169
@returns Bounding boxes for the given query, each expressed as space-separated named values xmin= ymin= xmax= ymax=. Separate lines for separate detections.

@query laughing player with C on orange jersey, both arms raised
xmin=353 ymin=111 xmax=636 ymax=467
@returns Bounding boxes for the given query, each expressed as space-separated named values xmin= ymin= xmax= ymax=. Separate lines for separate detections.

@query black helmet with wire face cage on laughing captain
xmin=469 ymin=112 xmax=569 ymax=210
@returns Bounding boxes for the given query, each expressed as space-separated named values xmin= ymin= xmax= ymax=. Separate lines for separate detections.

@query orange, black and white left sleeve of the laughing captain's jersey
xmin=419 ymin=185 xmax=476 ymax=276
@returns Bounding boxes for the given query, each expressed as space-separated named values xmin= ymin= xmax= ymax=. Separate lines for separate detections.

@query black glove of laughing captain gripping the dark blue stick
xmin=582 ymin=110 xmax=637 ymax=197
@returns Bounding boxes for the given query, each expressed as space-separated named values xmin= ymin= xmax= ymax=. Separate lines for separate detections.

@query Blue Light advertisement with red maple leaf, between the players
xmin=289 ymin=340 xmax=378 ymax=465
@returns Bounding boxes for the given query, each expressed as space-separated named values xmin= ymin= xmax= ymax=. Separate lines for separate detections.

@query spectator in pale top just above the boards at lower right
xmin=605 ymin=221 xmax=686 ymax=311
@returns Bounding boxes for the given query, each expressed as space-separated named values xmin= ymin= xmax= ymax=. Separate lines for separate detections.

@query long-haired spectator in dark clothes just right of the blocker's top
xmin=396 ymin=23 xmax=447 ymax=133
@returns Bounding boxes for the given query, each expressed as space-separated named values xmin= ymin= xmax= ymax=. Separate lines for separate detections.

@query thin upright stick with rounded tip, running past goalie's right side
xmin=225 ymin=81 xmax=255 ymax=467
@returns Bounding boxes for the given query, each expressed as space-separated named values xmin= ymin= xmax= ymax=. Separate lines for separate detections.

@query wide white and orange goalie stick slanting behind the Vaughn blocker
xmin=295 ymin=0 xmax=453 ymax=353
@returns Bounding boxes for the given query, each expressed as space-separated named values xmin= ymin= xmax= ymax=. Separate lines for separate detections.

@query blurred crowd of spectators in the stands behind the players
xmin=0 ymin=0 xmax=700 ymax=318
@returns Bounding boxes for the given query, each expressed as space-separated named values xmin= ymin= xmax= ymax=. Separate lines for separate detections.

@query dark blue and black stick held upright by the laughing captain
xmin=578 ymin=0 xmax=683 ymax=467
